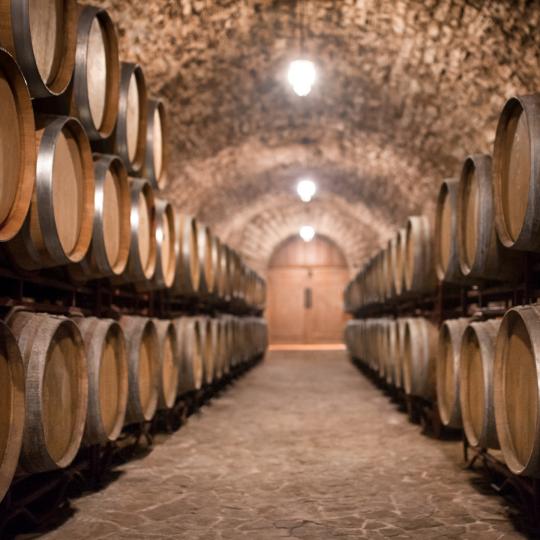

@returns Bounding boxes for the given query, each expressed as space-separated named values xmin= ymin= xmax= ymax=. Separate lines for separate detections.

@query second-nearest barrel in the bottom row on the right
xmin=459 ymin=319 xmax=501 ymax=448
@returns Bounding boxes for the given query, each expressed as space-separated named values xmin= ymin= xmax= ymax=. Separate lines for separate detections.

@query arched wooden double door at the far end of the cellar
xmin=267 ymin=235 xmax=349 ymax=344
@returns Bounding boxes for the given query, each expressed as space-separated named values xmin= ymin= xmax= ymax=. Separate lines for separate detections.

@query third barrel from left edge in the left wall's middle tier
xmin=69 ymin=154 xmax=131 ymax=281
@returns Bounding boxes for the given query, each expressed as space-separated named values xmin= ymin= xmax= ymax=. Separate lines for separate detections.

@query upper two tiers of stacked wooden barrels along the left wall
xmin=0 ymin=0 xmax=265 ymax=307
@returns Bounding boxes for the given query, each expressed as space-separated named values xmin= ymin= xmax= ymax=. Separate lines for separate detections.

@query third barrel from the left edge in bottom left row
xmin=74 ymin=317 xmax=128 ymax=445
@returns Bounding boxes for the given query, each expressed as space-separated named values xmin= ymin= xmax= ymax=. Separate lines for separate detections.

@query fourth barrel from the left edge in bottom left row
xmin=120 ymin=316 xmax=161 ymax=424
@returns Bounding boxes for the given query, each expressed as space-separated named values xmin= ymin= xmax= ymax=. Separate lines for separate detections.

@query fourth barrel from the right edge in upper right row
xmin=404 ymin=216 xmax=437 ymax=293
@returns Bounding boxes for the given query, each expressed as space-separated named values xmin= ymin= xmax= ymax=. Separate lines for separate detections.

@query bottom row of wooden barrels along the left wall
xmin=0 ymin=310 xmax=267 ymax=500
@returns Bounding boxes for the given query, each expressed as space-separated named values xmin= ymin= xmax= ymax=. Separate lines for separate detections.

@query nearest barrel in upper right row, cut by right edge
xmin=493 ymin=94 xmax=540 ymax=252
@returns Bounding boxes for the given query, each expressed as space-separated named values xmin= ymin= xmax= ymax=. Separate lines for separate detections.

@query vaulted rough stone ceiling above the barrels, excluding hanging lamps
xmin=98 ymin=0 xmax=540 ymax=270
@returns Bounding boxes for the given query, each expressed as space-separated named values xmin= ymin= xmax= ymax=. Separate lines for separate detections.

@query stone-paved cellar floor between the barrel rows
xmin=37 ymin=352 xmax=524 ymax=540
